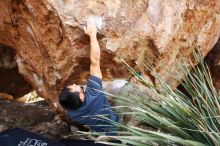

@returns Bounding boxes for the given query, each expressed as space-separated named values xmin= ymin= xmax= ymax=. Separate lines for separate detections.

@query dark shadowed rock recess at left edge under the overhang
xmin=0 ymin=45 xmax=32 ymax=99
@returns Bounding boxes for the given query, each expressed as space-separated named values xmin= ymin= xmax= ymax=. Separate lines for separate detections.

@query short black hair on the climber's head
xmin=59 ymin=87 xmax=82 ymax=110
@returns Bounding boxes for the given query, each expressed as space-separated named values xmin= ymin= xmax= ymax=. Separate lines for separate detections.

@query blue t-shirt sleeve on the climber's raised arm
xmin=86 ymin=75 xmax=103 ymax=95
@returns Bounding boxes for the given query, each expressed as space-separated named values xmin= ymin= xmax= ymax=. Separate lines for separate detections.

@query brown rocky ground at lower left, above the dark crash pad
xmin=0 ymin=99 xmax=84 ymax=140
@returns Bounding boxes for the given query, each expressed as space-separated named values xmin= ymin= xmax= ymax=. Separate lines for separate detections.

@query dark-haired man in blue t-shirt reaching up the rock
xmin=59 ymin=18 xmax=119 ymax=135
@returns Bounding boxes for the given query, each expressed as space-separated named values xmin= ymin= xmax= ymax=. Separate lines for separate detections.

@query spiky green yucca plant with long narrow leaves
xmin=85 ymin=53 xmax=220 ymax=146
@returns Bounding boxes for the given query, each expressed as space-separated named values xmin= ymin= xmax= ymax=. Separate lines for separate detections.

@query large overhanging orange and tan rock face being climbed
xmin=0 ymin=0 xmax=220 ymax=112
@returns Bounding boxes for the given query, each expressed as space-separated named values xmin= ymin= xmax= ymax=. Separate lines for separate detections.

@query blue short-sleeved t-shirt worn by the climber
xmin=68 ymin=75 xmax=119 ymax=135
